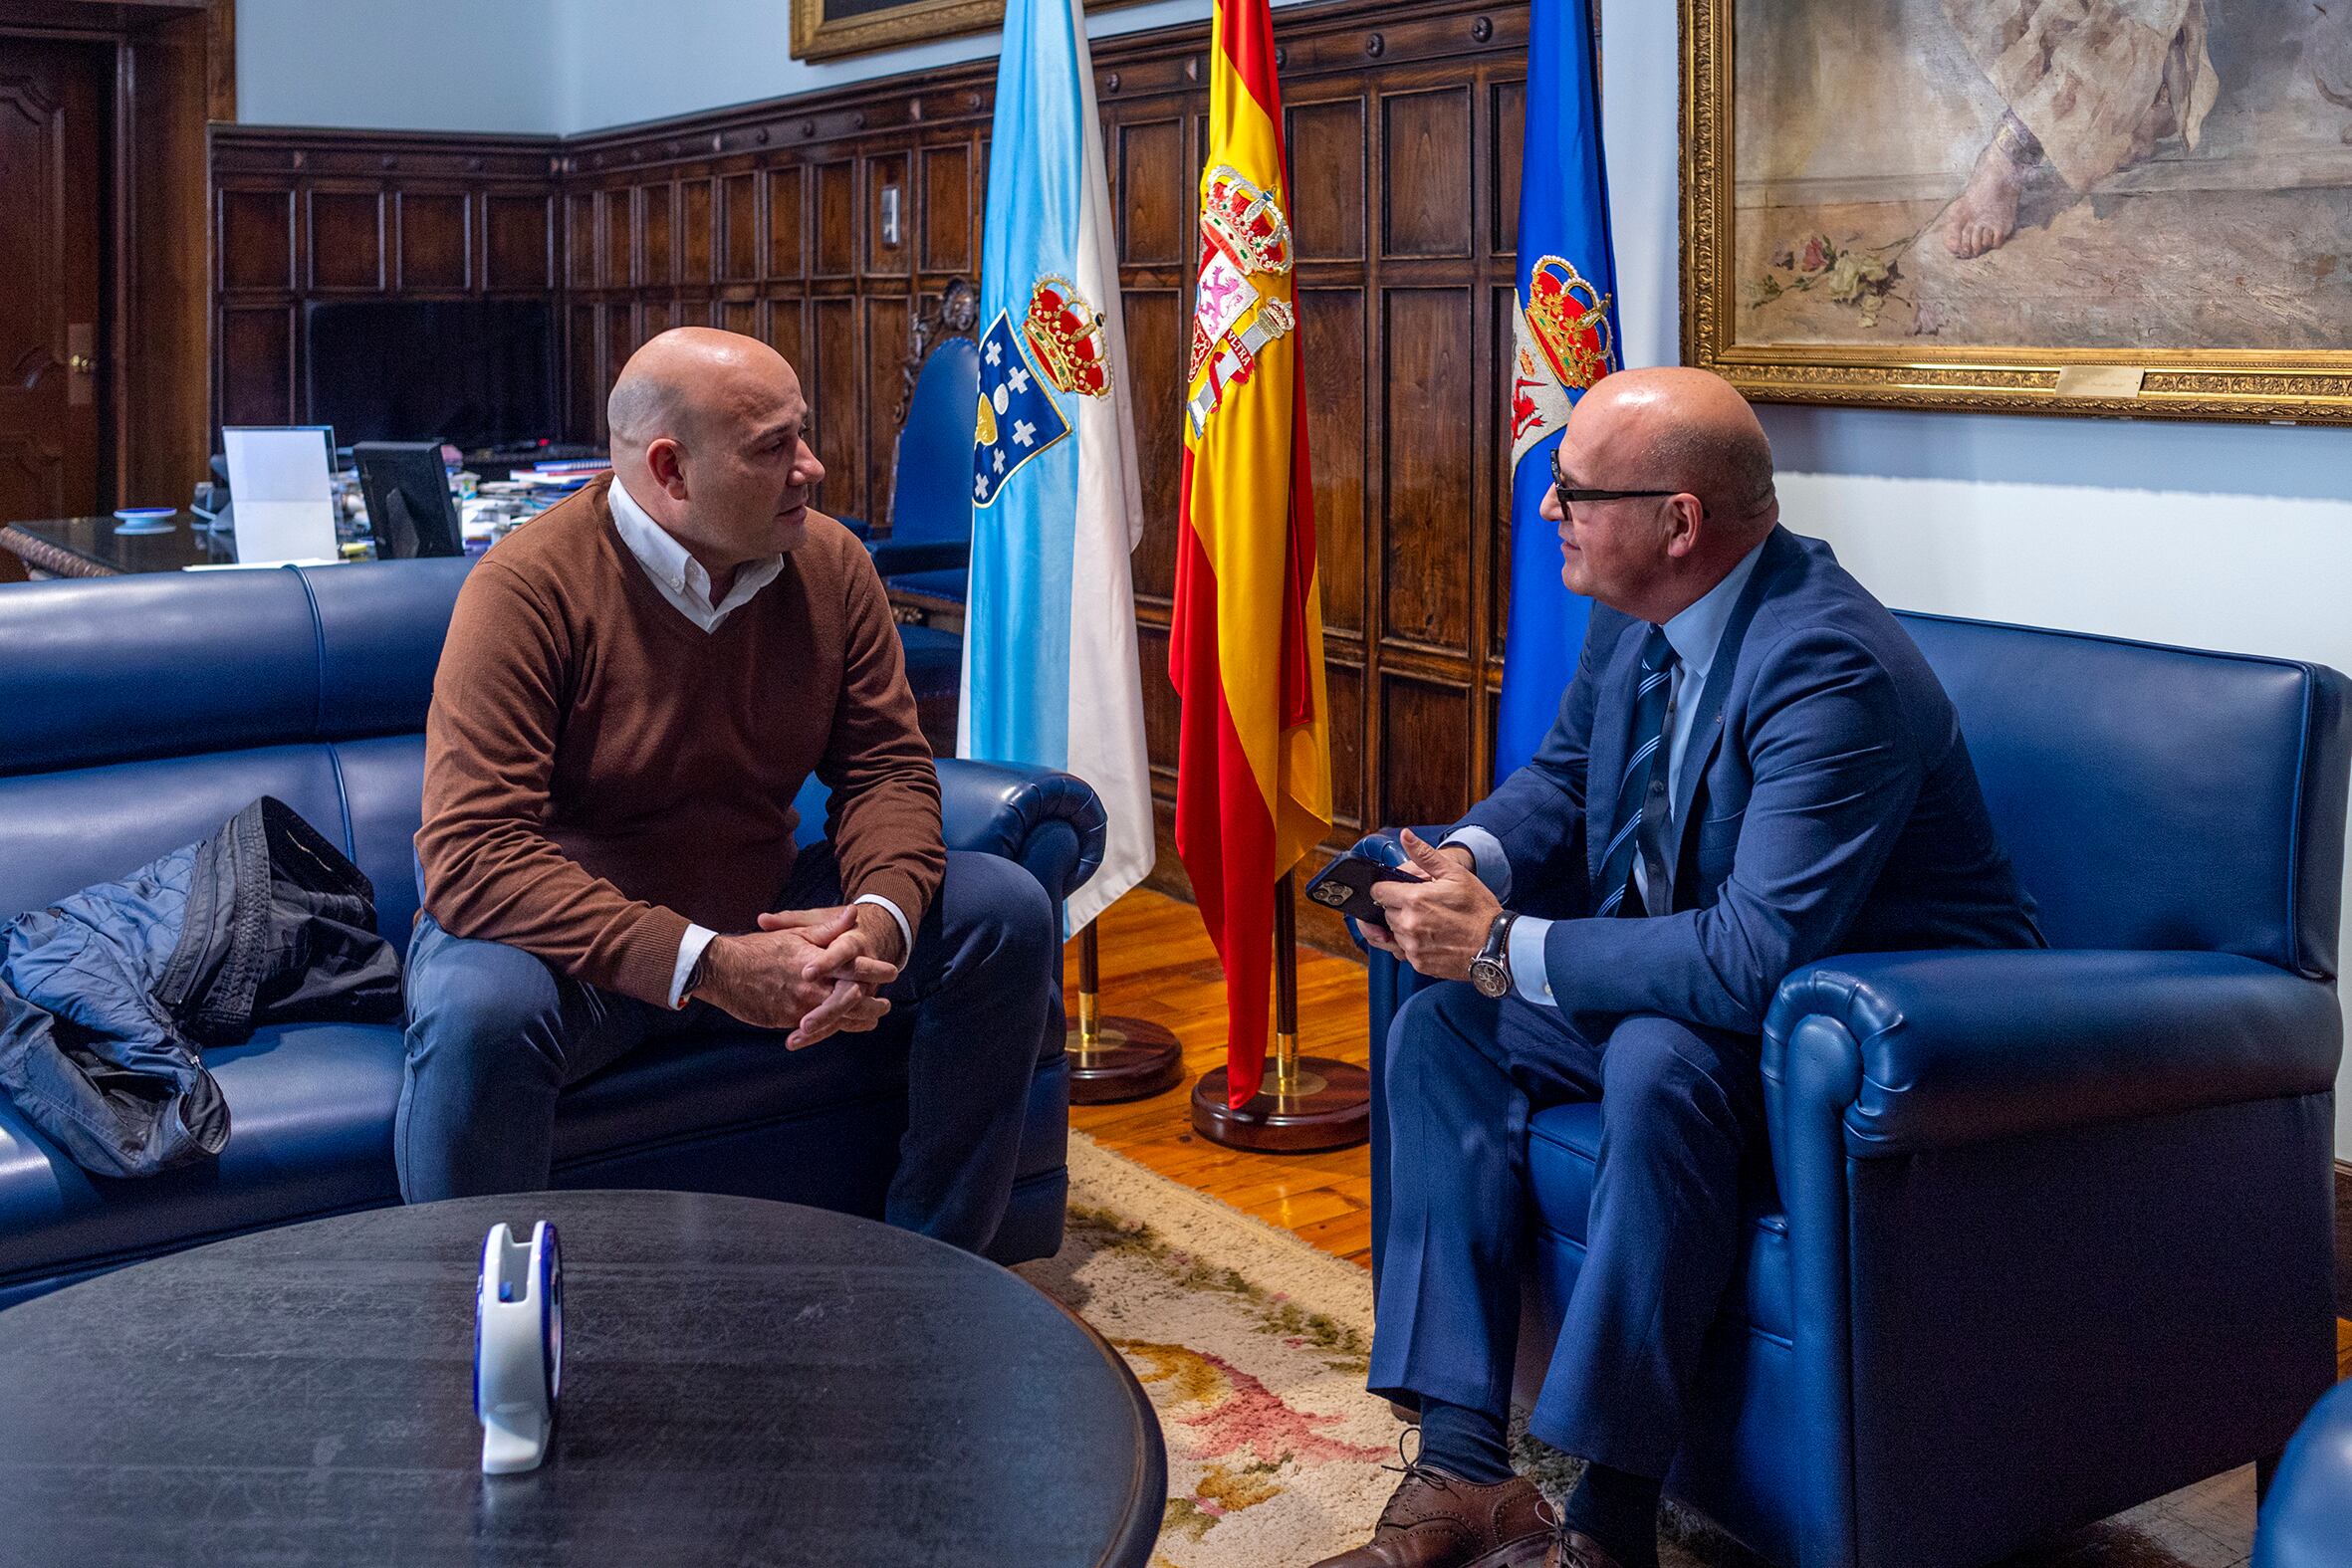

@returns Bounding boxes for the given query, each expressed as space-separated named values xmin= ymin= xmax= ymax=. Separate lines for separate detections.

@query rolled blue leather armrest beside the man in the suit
xmin=1764 ymin=950 xmax=2343 ymax=1159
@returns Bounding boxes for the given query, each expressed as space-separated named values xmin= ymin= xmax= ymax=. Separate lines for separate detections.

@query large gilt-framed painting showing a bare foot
xmin=1682 ymin=0 xmax=2352 ymax=423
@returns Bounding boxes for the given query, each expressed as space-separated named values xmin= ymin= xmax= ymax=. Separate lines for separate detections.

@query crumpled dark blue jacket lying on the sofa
xmin=0 ymin=796 xmax=400 ymax=1176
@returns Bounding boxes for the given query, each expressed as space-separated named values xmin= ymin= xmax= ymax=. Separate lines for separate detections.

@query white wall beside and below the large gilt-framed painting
xmin=1602 ymin=0 xmax=2352 ymax=1159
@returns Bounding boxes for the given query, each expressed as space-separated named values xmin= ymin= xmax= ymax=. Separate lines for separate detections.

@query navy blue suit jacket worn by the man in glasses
xmin=1461 ymin=527 xmax=2044 ymax=1034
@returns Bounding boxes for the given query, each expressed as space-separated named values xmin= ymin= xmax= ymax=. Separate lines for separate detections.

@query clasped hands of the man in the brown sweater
xmin=696 ymin=903 xmax=905 ymax=1051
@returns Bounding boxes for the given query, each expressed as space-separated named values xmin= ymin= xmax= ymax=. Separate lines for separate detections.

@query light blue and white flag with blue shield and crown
xmin=955 ymin=0 xmax=1152 ymax=936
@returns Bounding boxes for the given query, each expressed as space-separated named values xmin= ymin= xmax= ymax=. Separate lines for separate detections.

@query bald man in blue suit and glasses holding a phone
xmin=1326 ymin=369 xmax=2041 ymax=1568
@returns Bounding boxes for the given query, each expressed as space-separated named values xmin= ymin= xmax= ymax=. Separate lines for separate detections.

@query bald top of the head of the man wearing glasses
xmin=1576 ymin=364 xmax=1780 ymax=536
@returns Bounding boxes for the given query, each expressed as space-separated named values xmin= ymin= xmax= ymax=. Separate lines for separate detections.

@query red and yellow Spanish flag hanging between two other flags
xmin=1169 ymin=0 xmax=1331 ymax=1107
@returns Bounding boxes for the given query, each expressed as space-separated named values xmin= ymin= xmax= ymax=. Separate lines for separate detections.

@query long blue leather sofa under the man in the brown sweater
xmin=0 ymin=560 xmax=1103 ymax=1307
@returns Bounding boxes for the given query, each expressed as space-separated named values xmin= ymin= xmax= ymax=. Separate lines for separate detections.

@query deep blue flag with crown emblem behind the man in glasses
xmin=1494 ymin=0 xmax=1618 ymax=781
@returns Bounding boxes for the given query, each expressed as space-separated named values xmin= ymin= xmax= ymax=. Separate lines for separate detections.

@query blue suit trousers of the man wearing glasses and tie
xmin=1371 ymin=983 xmax=1764 ymax=1478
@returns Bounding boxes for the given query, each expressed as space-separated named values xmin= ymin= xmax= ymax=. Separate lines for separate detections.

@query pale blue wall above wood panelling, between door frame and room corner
xmin=238 ymin=0 xmax=563 ymax=136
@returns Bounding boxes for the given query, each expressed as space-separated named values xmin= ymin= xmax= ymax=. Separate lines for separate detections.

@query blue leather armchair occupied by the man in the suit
xmin=1366 ymin=616 xmax=2347 ymax=1568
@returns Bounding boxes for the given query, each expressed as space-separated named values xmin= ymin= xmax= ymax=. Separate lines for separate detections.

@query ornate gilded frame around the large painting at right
xmin=1677 ymin=0 xmax=2352 ymax=425
